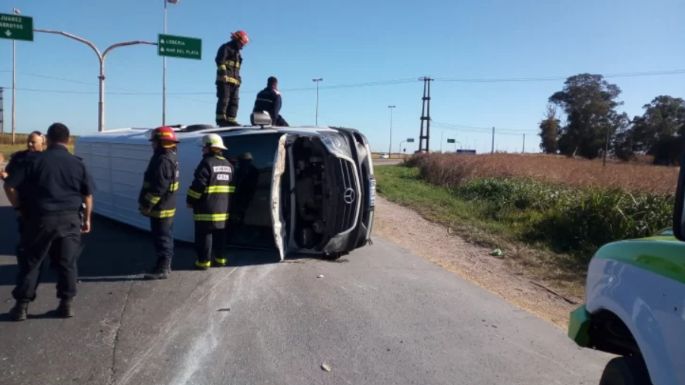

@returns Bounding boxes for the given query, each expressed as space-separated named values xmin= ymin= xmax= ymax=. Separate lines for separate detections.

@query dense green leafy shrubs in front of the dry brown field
xmin=453 ymin=178 xmax=673 ymax=263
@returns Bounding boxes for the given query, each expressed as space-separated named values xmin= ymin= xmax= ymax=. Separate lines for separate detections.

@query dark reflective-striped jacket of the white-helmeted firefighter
xmin=186 ymin=153 xmax=234 ymax=229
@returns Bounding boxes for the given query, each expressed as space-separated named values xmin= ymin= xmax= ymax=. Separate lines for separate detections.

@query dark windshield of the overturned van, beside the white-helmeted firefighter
xmin=224 ymin=133 xmax=281 ymax=248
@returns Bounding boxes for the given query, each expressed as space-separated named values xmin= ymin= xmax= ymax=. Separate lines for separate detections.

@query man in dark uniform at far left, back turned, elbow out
xmin=5 ymin=123 xmax=93 ymax=321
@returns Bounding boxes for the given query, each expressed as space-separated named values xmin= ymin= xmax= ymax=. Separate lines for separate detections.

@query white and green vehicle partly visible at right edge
xmin=568 ymin=163 xmax=685 ymax=385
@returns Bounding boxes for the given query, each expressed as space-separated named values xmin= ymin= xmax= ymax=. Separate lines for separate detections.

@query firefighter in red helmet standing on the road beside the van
xmin=138 ymin=126 xmax=179 ymax=279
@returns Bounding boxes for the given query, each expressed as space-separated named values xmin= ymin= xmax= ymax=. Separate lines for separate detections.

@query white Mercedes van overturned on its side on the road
xmin=75 ymin=125 xmax=376 ymax=259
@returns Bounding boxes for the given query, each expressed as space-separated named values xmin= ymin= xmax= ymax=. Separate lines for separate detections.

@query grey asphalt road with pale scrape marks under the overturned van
xmin=0 ymin=184 xmax=609 ymax=385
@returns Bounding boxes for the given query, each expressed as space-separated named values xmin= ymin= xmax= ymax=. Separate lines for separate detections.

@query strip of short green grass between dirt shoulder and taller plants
xmin=375 ymin=165 xmax=600 ymax=298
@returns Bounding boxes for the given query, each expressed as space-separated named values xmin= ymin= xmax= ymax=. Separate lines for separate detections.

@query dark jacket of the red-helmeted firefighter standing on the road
xmin=138 ymin=148 xmax=179 ymax=218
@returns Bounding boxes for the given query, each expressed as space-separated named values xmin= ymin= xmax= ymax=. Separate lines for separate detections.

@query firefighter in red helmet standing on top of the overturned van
xmin=214 ymin=31 xmax=250 ymax=127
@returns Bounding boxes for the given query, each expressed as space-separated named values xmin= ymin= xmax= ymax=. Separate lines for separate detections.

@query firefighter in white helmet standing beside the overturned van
xmin=186 ymin=134 xmax=233 ymax=270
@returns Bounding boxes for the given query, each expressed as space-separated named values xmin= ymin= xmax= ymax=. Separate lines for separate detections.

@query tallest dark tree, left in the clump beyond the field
xmin=549 ymin=74 xmax=622 ymax=158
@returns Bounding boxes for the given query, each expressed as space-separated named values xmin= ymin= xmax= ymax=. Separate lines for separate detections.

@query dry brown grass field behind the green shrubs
xmin=412 ymin=154 xmax=679 ymax=195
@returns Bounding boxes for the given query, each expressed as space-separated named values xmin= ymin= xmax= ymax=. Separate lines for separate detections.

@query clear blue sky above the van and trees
xmin=0 ymin=0 xmax=685 ymax=152
